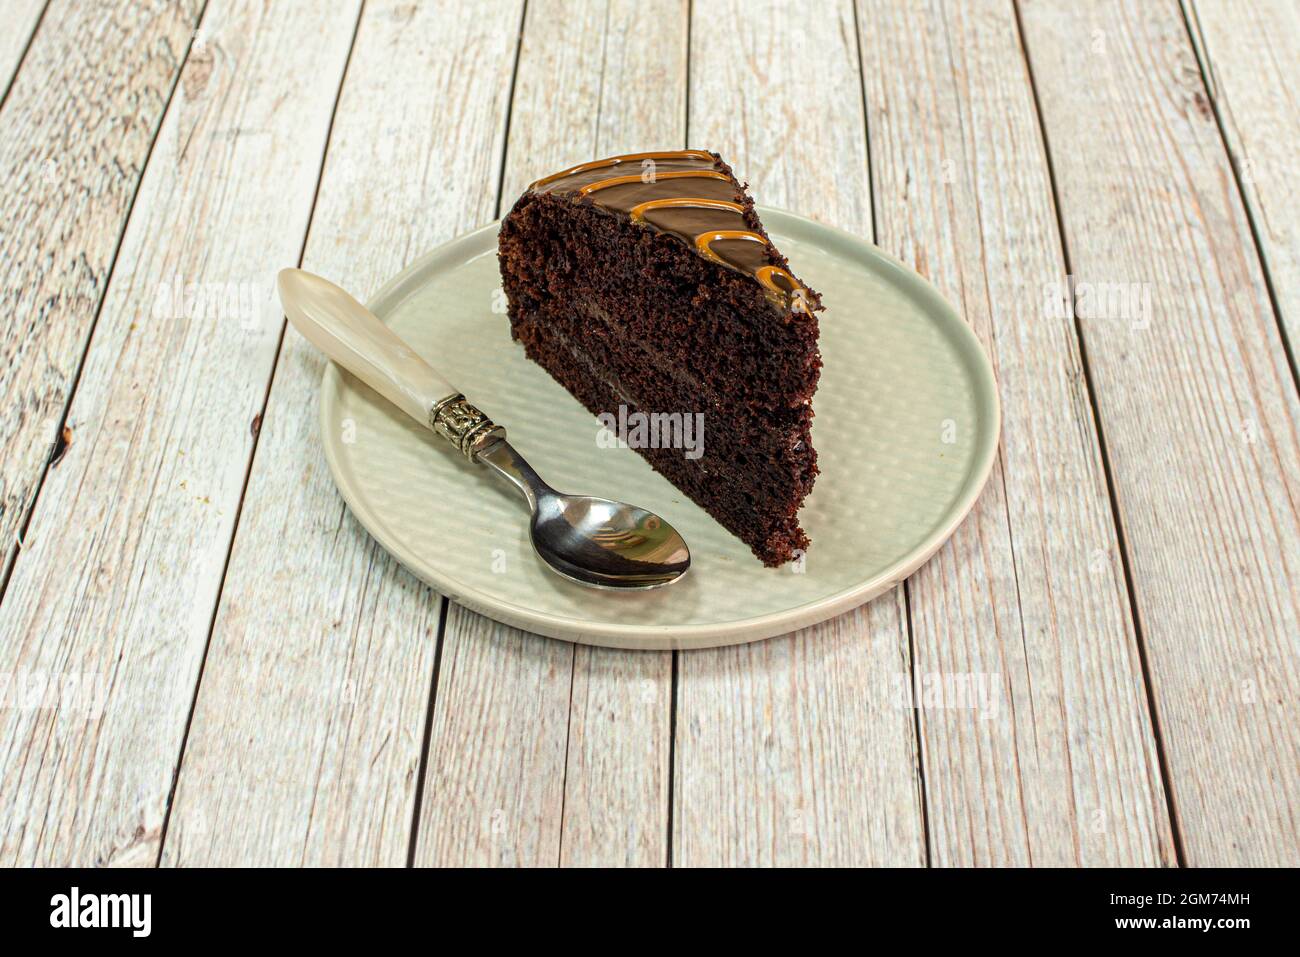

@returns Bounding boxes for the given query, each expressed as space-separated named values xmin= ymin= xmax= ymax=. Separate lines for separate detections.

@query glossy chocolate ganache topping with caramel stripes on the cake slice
xmin=528 ymin=150 xmax=813 ymax=313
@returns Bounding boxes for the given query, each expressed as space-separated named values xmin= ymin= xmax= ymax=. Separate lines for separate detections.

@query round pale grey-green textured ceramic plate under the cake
xmin=321 ymin=208 xmax=998 ymax=649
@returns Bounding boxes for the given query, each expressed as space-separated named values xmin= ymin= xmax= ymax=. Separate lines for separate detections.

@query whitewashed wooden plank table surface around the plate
xmin=0 ymin=0 xmax=1300 ymax=866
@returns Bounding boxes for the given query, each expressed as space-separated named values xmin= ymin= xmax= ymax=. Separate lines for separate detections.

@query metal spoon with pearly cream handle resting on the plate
xmin=278 ymin=269 xmax=690 ymax=589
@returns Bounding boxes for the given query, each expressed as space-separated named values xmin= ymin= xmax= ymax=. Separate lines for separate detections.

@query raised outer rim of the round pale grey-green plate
xmin=319 ymin=205 xmax=1002 ymax=650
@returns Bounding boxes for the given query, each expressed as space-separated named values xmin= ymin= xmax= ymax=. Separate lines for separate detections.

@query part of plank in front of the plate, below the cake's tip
xmin=672 ymin=600 xmax=926 ymax=867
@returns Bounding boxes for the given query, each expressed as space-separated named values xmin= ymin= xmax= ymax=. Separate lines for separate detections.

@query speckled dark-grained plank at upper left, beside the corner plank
xmin=0 ymin=0 xmax=200 ymax=581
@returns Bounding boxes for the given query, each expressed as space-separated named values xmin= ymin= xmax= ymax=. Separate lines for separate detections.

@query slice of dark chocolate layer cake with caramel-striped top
xmin=499 ymin=150 xmax=822 ymax=566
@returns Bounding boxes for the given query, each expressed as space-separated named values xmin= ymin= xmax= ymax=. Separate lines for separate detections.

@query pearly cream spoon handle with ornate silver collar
xmin=277 ymin=269 xmax=506 ymax=459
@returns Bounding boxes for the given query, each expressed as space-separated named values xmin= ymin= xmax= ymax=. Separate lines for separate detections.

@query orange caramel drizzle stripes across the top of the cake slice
xmin=528 ymin=150 xmax=813 ymax=316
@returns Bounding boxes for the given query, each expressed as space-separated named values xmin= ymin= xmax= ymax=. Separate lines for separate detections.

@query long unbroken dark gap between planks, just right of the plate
xmin=1011 ymin=0 xmax=1187 ymax=867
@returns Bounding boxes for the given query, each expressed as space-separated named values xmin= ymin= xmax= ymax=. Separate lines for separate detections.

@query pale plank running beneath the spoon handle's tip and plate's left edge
xmin=163 ymin=0 xmax=521 ymax=866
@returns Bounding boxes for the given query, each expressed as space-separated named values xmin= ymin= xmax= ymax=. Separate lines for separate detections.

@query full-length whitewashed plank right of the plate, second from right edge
xmin=1022 ymin=0 xmax=1300 ymax=866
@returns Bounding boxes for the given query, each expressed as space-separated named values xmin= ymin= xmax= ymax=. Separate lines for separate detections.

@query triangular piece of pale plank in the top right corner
xmin=1184 ymin=0 xmax=1300 ymax=354
